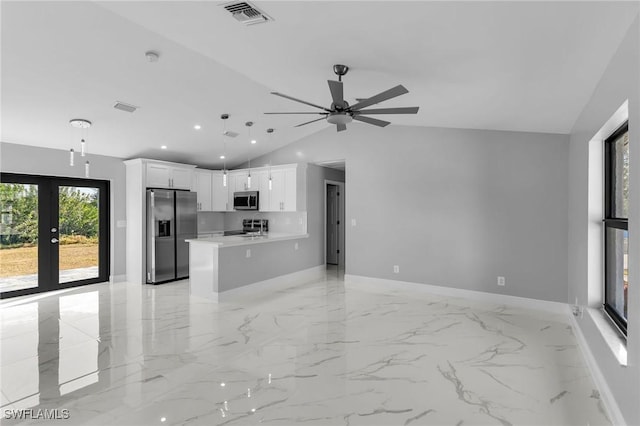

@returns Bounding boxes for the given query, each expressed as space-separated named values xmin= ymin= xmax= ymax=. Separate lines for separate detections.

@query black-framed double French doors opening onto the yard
xmin=0 ymin=173 xmax=109 ymax=298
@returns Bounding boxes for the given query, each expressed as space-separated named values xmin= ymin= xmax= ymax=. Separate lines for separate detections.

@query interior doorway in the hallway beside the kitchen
xmin=325 ymin=180 xmax=345 ymax=270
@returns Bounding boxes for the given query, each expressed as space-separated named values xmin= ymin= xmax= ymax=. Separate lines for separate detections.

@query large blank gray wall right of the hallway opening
xmin=248 ymin=123 xmax=569 ymax=302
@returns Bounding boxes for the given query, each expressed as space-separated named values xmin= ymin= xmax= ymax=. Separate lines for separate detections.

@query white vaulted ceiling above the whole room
xmin=1 ymin=1 xmax=638 ymax=167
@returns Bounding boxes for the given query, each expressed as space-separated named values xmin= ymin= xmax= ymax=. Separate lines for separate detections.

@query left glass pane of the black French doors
xmin=0 ymin=183 xmax=38 ymax=293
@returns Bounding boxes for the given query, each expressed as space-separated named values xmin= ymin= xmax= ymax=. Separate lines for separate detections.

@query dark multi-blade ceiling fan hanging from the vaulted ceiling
xmin=265 ymin=64 xmax=419 ymax=132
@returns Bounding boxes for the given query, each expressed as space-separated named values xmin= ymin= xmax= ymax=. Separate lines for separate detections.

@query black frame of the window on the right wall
xmin=602 ymin=120 xmax=629 ymax=338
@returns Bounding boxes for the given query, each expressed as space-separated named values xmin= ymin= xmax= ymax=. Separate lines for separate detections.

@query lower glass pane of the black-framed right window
xmin=605 ymin=227 xmax=629 ymax=320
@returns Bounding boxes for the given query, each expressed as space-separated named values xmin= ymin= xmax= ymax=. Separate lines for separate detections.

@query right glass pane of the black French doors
xmin=58 ymin=185 xmax=100 ymax=284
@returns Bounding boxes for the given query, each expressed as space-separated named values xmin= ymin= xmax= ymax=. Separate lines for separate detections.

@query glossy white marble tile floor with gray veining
xmin=0 ymin=271 xmax=610 ymax=426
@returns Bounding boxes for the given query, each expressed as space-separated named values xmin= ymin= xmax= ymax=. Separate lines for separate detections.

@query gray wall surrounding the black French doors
xmin=0 ymin=142 xmax=126 ymax=279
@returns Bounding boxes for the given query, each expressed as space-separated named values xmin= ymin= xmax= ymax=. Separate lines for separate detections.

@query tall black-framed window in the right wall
xmin=604 ymin=123 xmax=629 ymax=335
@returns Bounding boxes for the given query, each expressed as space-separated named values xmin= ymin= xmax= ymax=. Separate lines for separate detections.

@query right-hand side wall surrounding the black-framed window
xmin=568 ymin=18 xmax=640 ymax=425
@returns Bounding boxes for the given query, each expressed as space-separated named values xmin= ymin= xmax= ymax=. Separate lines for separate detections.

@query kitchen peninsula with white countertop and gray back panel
xmin=186 ymin=232 xmax=309 ymax=301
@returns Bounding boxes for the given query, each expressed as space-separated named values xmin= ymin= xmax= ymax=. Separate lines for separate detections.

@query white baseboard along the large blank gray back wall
xmin=344 ymin=274 xmax=571 ymax=315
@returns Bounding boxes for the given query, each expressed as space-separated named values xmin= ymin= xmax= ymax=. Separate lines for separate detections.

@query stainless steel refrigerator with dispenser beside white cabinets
xmin=147 ymin=189 xmax=198 ymax=284
